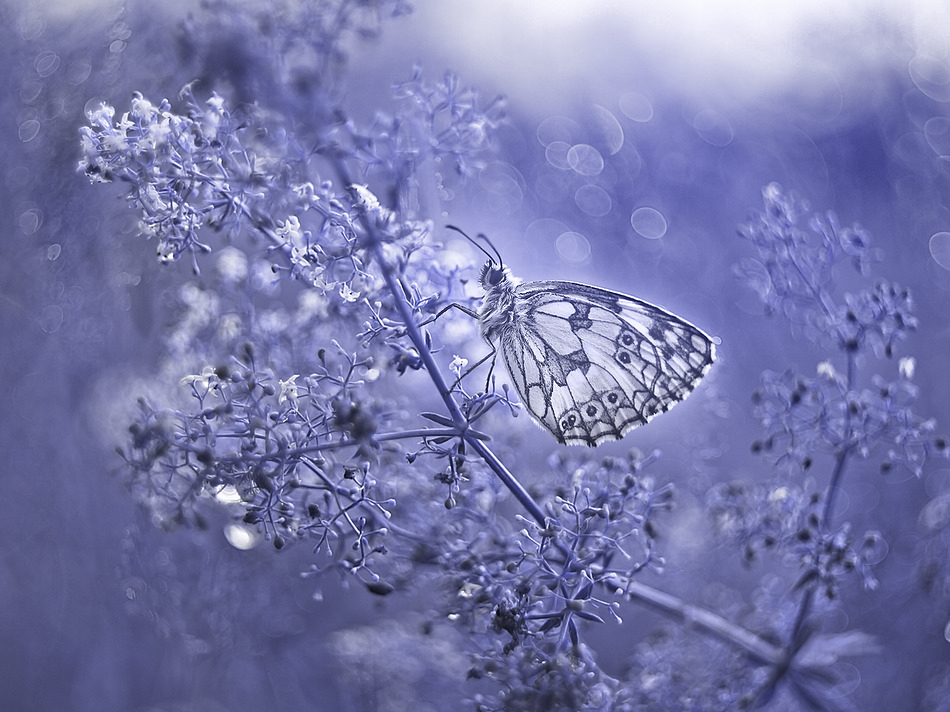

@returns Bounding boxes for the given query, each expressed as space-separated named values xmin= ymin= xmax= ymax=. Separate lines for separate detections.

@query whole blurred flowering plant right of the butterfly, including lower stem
xmin=720 ymin=184 xmax=947 ymax=702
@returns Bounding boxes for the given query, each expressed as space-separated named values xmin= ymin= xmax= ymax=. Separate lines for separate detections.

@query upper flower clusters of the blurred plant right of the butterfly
xmin=740 ymin=183 xmax=946 ymax=482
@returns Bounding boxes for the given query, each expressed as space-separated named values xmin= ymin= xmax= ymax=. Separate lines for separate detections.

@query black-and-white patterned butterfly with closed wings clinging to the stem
xmin=450 ymin=226 xmax=716 ymax=447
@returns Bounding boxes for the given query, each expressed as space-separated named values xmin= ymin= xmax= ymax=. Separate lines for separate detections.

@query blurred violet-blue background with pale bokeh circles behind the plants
xmin=0 ymin=0 xmax=950 ymax=710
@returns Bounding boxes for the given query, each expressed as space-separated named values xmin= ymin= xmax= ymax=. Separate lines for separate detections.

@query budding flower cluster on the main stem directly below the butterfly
xmin=451 ymin=451 xmax=672 ymax=652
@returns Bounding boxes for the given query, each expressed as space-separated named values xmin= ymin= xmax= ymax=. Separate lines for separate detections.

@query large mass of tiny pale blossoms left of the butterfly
xmin=82 ymin=76 xmax=513 ymax=592
